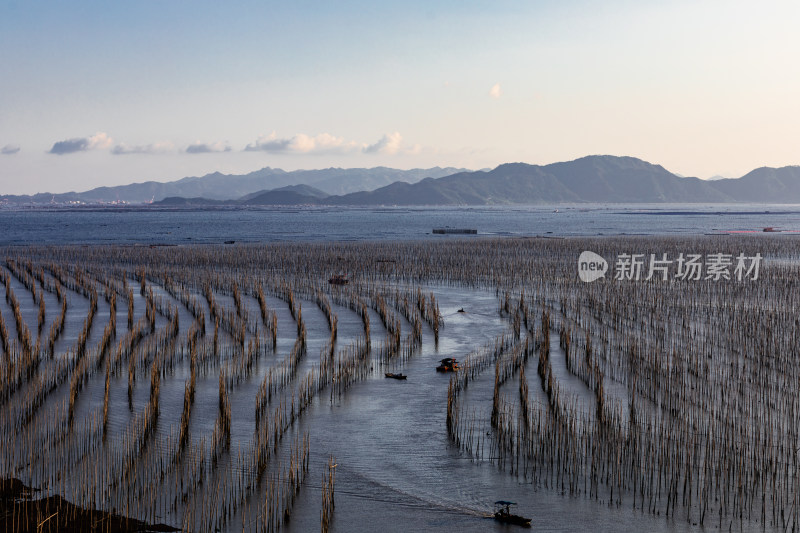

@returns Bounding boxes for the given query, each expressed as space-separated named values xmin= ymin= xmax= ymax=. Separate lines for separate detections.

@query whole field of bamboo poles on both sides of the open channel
xmin=0 ymin=236 xmax=800 ymax=529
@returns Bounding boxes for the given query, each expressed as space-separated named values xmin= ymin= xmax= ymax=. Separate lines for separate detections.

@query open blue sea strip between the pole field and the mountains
xmin=0 ymin=204 xmax=800 ymax=245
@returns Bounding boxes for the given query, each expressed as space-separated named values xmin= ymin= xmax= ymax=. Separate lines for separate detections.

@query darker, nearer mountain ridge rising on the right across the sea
xmin=158 ymin=156 xmax=800 ymax=205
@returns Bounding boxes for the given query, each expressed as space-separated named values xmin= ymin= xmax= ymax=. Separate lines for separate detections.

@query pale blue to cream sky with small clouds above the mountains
xmin=0 ymin=0 xmax=800 ymax=194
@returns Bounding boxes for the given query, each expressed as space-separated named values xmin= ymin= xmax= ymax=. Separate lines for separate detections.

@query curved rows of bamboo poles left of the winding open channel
xmin=0 ymin=243 xmax=450 ymax=531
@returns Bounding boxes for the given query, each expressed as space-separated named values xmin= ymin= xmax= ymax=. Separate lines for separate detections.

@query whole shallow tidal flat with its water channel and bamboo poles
xmin=0 ymin=238 xmax=800 ymax=531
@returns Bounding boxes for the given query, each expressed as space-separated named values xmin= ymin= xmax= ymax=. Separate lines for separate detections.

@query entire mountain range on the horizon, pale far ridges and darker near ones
xmin=0 ymin=156 xmax=800 ymax=207
